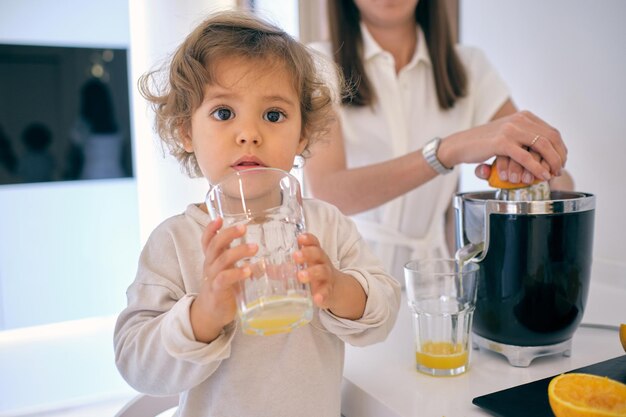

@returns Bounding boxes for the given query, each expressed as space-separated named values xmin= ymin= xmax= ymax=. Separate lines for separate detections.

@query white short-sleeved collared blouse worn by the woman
xmin=311 ymin=24 xmax=509 ymax=282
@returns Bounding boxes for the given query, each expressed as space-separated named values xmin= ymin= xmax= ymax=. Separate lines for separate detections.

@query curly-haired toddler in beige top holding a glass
xmin=114 ymin=12 xmax=400 ymax=417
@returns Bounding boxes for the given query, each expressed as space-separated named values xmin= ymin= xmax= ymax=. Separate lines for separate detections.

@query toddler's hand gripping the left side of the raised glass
xmin=190 ymin=218 xmax=258 ymax=343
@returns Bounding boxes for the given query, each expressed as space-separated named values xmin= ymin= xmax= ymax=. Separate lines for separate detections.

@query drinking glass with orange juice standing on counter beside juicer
xmin=404 ymin=259 xmax=479 ymax=376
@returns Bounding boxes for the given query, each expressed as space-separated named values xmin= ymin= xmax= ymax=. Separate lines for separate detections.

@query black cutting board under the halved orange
xmin=472 ymin=355 xmax=626 ymax=417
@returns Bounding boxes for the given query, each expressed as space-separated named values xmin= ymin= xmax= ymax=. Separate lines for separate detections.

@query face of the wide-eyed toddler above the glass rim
xmin=184 ymin=58 xmax=306 ymax=184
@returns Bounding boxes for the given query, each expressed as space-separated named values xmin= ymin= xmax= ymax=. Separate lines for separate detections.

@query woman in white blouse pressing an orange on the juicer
xmin=305 ymin=0 xmax=572 ymax=280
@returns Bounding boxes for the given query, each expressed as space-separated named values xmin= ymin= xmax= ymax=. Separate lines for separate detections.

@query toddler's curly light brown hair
xmin=139 ymin=11 xmax=333 ymax=177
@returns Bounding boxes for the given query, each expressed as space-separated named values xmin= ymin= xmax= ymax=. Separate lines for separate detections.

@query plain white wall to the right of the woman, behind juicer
xmin=460 ymin=0 xmax=626 ymax=285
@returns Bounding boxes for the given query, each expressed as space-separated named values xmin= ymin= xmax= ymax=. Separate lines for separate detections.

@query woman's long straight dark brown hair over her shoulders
xmin=328 ymin=0 xmax=467 ymax=109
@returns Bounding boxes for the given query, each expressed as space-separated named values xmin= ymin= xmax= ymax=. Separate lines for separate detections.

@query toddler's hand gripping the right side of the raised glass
xmin=294 ymin=233 xmax=366 ymax=320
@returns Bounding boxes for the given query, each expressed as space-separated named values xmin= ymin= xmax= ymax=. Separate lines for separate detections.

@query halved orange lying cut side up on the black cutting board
xmin=548 ymin=373 xmax=626 ymax=417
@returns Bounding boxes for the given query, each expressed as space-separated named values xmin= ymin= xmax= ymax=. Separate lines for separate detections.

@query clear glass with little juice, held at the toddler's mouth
xmin=206 ymin=168 xmax=313 ymax=336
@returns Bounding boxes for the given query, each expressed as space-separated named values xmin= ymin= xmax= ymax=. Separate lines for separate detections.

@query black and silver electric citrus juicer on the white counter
xmin=454 ymin=182 xmax=595 ymax=367
